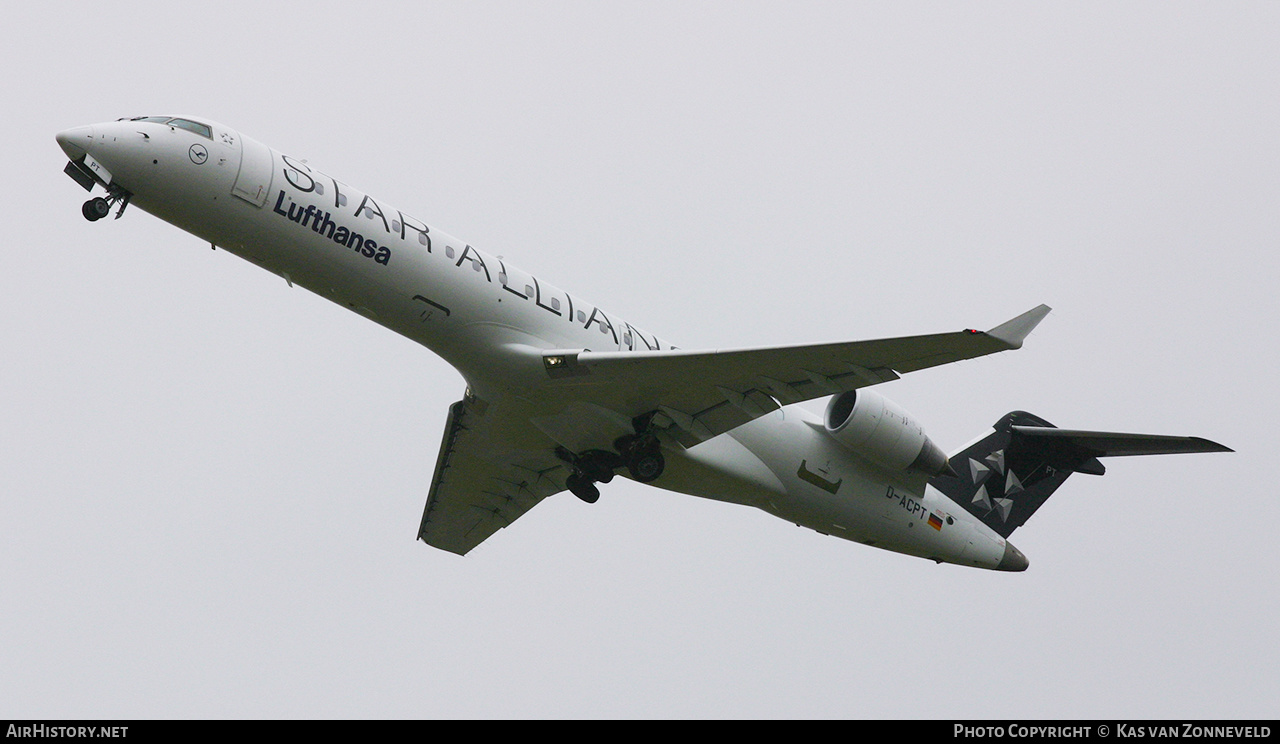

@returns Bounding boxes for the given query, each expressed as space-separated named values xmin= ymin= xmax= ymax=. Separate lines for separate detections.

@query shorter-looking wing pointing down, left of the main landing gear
xmin=417 ymin=396 xmax=568 ymax=556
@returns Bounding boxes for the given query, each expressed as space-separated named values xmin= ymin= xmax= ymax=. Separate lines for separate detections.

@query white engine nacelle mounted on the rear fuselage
xmin=823 ymin=389 xmax=950 ymax=475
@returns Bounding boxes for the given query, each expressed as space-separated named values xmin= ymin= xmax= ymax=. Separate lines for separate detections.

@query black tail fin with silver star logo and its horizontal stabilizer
xmin=929 ymin=411 xmax=1231 ymax=538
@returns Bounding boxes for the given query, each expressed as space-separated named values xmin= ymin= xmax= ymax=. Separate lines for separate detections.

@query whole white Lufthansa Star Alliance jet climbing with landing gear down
xmin=56 ymin=115 xmax=1231 ymax=571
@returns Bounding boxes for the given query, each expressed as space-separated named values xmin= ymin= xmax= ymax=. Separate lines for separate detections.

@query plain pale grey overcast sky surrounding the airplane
xmin=0 ymin=0 xmax=1280 ymax=718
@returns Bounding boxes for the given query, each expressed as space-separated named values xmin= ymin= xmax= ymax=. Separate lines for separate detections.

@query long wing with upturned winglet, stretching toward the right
xmin=543 ymin=305 xmax=1050 ymax=447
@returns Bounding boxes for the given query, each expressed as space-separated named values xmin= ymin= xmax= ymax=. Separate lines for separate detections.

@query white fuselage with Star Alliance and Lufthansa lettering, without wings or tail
xmin=58 ymin=115 xmax=1025 ymax=569
